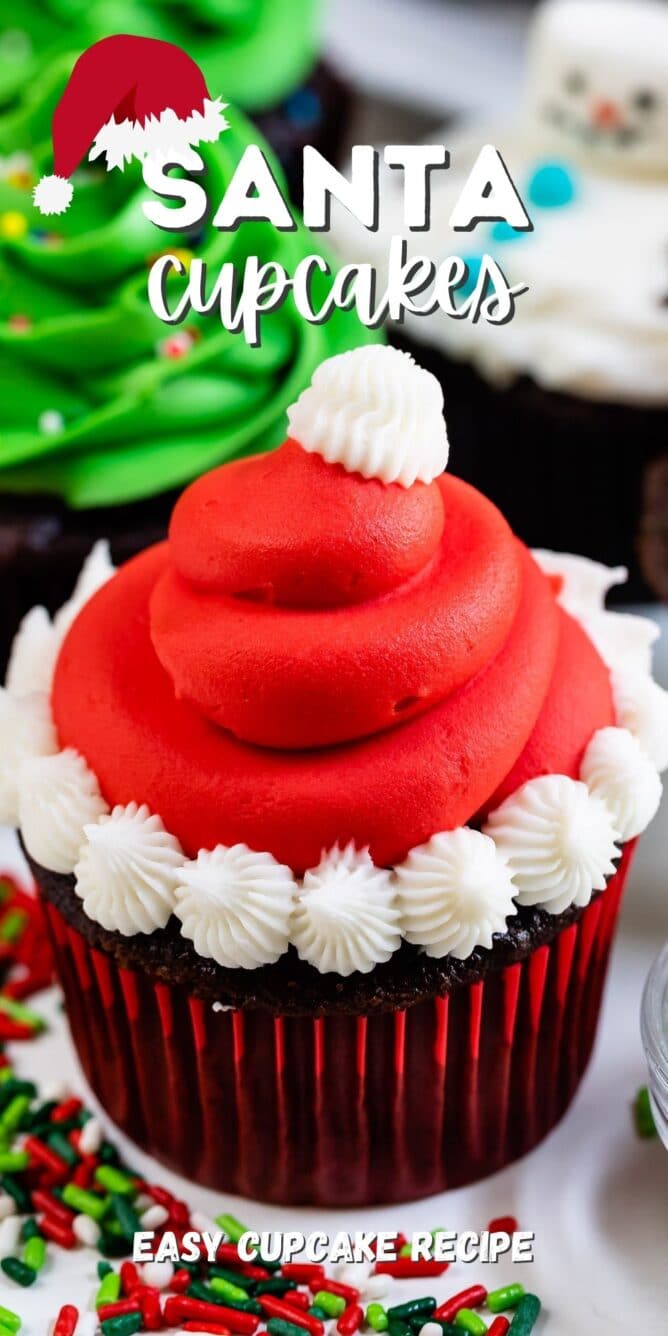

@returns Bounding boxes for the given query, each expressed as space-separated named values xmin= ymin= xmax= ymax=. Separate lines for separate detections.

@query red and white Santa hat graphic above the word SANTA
xmin=33 ymin=35 xmax=227 ymax=214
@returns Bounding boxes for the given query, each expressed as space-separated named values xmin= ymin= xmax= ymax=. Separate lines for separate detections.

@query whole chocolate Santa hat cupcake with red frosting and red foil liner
xmin=0 ymin=347 xmax=668 ymax=1206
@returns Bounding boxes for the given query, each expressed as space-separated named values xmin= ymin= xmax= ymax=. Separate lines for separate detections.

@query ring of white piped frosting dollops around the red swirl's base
xmin=0 ymin=546 xmax=668 ymax=977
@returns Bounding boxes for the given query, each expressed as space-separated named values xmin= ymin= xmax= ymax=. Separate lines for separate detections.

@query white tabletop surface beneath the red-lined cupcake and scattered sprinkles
xmin=0 ymin=613 xmax=668 ymax=1336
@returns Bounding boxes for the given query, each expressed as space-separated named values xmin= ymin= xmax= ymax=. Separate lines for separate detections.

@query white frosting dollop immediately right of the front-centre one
xmin=397 ymin=826 xmax=517 ymax=961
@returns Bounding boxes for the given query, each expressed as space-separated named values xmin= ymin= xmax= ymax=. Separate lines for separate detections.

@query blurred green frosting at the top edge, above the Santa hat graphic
xmin=0 ymin=0 xmax=321 ymax=112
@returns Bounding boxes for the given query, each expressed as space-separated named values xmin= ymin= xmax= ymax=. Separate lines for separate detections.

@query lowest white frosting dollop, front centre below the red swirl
xmin=290 ymin=844 xmax=401 ymax=978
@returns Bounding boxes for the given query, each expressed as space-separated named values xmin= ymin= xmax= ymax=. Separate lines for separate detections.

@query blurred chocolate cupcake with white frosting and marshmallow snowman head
xmin=337 ymin=0 xmax=668 ymax=599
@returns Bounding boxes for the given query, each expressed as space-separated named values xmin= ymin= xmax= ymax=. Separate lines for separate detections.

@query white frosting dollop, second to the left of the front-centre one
xmin=75 ymin=803 xmax=183 ymax=937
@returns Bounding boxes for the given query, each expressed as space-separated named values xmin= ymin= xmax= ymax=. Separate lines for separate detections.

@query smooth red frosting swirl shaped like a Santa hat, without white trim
xmin=53 ymin=442 xmax=613 ymax=872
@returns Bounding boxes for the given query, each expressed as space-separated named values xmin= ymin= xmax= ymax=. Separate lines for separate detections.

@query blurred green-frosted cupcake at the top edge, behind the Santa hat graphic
xmin=0 ymin=0 xmax=351 ymax=198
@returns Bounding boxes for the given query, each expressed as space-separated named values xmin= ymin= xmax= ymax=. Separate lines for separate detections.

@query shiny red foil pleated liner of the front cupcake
xmin=40 ymin=846 xmax=632 ymax=1206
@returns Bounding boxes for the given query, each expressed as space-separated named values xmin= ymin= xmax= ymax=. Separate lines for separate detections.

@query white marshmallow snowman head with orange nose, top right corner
xmin=528 ymin=0 xmax=668 ymax=176
